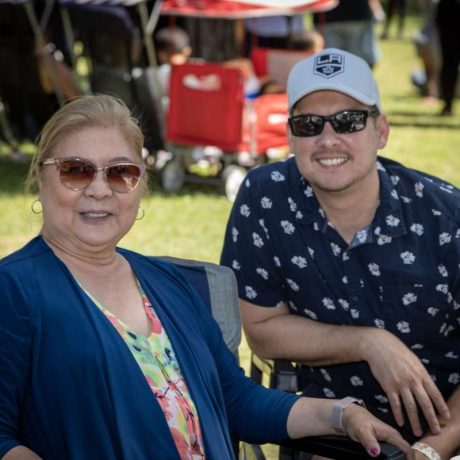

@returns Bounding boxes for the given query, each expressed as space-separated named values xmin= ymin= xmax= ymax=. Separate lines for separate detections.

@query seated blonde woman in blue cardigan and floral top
xmin=0 ymin=95 xmax=411 ymax=460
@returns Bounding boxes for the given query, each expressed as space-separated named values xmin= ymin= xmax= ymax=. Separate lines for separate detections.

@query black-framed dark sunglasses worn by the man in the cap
xmin=288 ymin=107 xmax=380 ymax=137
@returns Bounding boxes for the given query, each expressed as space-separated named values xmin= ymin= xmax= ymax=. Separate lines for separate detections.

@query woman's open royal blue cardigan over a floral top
xmin=0 ymin=237 xmax=297 ymax=460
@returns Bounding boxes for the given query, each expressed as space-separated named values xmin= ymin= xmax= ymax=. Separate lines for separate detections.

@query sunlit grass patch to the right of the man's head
xmin=376 ymin=33 xmax=460 ymax=186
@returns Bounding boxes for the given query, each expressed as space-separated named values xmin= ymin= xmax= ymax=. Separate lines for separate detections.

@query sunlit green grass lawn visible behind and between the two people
xmin=0 ymin=17 xmax=460 ymax=455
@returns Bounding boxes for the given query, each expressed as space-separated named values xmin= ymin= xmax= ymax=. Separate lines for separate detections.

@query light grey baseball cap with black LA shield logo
xmin=287 ymin=48 xmax=382 ymax=112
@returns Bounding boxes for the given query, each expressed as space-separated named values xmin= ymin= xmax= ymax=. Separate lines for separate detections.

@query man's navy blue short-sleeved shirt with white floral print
xmin=221 ymin=157 xmax=460 ymax=422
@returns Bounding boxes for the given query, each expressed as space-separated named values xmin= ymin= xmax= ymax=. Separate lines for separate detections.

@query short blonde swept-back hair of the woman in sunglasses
xmin=26 ymin=94 xmax=148 ymax=191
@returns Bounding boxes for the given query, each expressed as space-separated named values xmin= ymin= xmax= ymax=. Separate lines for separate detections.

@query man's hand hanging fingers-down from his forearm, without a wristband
xmin=362 ymin=329 xmax=450 ymax=436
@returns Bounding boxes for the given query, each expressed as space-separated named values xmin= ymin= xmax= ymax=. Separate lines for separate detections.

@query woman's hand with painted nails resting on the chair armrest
xmin=342 ymin=404 xmax=415 ymax=460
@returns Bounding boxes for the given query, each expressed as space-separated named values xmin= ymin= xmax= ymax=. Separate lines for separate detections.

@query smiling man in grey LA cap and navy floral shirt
xmin=221 ymin=49 xmax=460 ymax=459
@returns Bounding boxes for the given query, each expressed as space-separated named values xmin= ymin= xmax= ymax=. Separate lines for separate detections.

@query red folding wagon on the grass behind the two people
xmin=162 ymin=63 xmax=288 ymax=200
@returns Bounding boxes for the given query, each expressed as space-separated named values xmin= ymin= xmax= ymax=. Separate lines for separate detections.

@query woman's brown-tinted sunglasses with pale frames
xmin=39 ymin=158 xmax=145 ymax=193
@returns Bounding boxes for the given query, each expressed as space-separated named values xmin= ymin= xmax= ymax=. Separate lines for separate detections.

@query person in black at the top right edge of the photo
xmin=436 ymin=0 xmax=460 ymax=116
